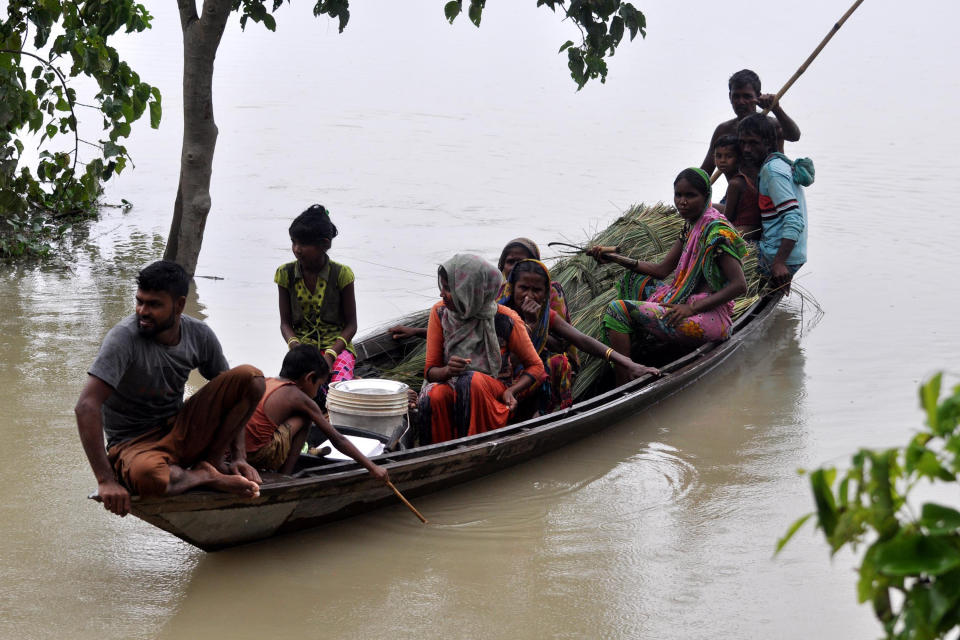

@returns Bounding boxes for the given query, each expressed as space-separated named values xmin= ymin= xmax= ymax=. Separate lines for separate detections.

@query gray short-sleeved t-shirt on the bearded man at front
xmin=88 ymin=314 xmax=229 ymax=448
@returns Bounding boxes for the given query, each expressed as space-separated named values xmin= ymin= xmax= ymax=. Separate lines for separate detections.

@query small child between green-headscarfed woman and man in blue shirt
xmin=713 ymin=136 xmax=760 ymax=241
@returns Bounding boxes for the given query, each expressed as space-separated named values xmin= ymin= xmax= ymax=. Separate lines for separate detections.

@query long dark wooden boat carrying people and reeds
xmin=118 ymin=293 xmax=781 ymax=551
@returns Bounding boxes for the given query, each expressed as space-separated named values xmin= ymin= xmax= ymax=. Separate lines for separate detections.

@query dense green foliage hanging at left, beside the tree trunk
xmin=0 ymin=0 xmax=161 ymax=258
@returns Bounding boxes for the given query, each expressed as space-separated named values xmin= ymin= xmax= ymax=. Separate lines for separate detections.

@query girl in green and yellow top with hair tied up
xmin=274 ymin=204 xmax=357 ymax=390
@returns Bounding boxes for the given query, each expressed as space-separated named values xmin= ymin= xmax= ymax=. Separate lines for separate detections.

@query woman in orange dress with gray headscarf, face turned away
xmin=418 ymin=254 xmax=546 ymax=444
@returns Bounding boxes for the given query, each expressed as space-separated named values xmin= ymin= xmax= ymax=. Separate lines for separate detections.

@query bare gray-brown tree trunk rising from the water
xmin=163 ymin=0 xmax=230 ymax=275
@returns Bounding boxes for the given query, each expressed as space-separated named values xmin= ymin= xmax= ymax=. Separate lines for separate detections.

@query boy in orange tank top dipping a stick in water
xmin=245 ymin=344 xmax=389 ymax=482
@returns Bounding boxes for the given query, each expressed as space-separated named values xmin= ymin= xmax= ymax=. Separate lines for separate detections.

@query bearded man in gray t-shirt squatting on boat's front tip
xmin=75 ymin=261 xmax=264 ymax=516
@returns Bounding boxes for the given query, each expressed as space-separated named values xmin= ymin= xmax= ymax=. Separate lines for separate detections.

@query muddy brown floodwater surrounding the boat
xmin=0 ymin=0 xmax=960 ymax=640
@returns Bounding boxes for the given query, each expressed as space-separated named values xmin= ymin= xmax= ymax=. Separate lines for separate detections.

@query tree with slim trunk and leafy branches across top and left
xmin=0 ymin=0 xmax=646 ymax=273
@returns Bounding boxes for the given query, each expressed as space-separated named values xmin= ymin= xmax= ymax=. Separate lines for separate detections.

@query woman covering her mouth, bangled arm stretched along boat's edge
xmin=499 ymin=259 xmax=659 ymax=420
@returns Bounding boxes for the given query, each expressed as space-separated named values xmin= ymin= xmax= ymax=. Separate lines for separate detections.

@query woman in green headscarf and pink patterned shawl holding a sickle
xmin=587 ymin=168 xmax=747 ymax=383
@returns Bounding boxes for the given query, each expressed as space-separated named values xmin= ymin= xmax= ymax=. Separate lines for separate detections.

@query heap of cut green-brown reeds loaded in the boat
xmin=383 ymin=203 xmax=759 ymax=399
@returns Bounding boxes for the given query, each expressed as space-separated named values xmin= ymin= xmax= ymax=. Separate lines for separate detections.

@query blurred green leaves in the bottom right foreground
xmin=777 ymin=374 xmax=960 ymax=640
